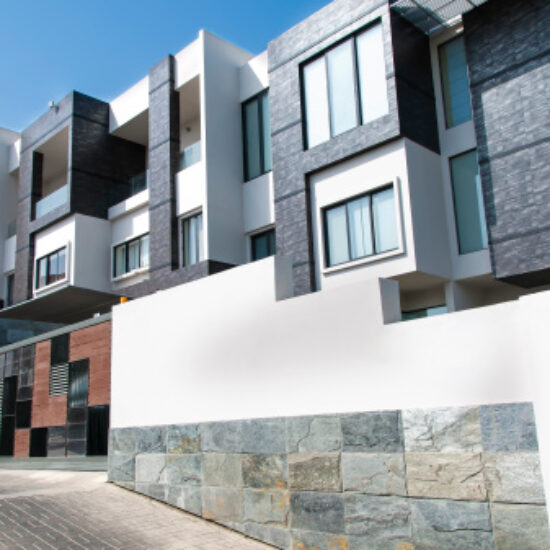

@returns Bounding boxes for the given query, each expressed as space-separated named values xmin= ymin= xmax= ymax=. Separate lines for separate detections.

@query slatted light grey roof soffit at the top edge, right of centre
xmin=390 ymin=0 xmax=487 ymax=34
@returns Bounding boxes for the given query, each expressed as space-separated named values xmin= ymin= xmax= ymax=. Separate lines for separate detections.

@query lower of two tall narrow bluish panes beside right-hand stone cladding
xmin=451 ymin=151 xmax=487 ymax=254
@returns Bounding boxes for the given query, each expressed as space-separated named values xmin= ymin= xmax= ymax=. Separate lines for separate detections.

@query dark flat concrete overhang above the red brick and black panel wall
xmin=0 ymin=286 xmax=120 ymax=324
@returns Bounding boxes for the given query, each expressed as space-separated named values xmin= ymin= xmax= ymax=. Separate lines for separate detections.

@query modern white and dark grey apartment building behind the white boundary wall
xmin=0 ymin=0 xmax=550 ymax=330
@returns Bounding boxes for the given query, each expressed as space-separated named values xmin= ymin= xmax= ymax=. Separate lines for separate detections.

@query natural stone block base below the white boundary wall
xmin=109 ymin=403 xmax=550 ymax=550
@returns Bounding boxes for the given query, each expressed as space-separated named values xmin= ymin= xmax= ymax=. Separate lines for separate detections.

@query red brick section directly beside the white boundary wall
xmin=69 ymin=321 xmax=111 ymax=406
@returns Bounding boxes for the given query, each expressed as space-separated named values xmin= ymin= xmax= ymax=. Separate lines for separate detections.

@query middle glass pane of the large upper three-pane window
xmin=327 ymin=40 xmax=357 ymax=136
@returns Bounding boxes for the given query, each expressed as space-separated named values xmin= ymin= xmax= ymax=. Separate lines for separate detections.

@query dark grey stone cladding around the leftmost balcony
xmin=14 ymin=92 xmax=145 ymax=302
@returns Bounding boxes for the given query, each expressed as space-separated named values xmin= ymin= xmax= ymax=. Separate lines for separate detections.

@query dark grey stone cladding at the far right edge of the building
xmin=464 ymin=0 xmax=550 ymax=287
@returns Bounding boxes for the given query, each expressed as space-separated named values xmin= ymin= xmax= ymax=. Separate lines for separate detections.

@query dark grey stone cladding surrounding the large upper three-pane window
xmin=268 ymin=0 xmax=438 ymax=294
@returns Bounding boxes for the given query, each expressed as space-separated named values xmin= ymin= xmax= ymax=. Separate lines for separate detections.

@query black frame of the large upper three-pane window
xmin=299 ymin=17 xmax=389 ymax=151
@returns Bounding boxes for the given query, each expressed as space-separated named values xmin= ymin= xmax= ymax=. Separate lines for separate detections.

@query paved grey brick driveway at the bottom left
xmin=0 ymin=470 xmax=272 ymax=550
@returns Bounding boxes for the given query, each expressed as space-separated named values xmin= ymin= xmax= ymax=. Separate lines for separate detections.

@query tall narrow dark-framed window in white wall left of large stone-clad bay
xmin=243 ymin=92 xmax=271 ymax=181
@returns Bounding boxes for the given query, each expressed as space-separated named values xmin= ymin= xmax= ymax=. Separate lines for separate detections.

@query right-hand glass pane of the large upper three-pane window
xmin=357 ymin=25 xmax=389 ymax=124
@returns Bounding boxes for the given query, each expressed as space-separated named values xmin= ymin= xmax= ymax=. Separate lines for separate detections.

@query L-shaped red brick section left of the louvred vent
xmin=31 ymin=340 xmax=67 ymax=428
